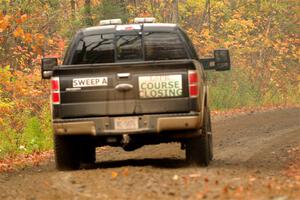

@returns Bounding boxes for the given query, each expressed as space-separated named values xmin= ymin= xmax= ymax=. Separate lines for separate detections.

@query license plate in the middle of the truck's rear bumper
xmin=114 ymin=117 xmax=139 ymax=130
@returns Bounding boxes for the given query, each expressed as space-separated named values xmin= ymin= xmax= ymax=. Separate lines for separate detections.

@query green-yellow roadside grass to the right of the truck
xmin=208 ymin=68 xmax=300 ymax=110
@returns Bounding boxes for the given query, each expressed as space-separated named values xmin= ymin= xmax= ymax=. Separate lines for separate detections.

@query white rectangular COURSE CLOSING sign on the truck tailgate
xmin=139 ymin=75 xmax=182 ymax=98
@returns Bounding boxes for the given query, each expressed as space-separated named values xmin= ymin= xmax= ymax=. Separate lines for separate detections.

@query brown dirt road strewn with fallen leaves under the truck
xmin=0 ymin=109 xmax=300 ymax=200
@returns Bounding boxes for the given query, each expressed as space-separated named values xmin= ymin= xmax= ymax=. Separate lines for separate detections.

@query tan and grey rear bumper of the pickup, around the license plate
xmin=53 ymin=112 xmax=202 ymax=136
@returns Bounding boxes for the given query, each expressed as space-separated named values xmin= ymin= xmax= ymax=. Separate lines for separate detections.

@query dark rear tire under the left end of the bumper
xmin=54 ymin=135 xmax=80 ymax=170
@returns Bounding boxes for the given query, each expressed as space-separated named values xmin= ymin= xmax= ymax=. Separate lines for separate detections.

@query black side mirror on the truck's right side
xmin=214 ymin=49 xmax=231 ymax=71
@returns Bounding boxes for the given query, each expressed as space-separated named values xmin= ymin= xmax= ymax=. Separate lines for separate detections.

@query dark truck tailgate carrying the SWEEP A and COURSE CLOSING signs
xmin=53 ymin=60 xmax=202 ymax=118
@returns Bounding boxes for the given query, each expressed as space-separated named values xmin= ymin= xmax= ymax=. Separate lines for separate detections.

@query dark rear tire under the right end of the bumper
xmin=185 ymin=108 xmax=212 ymax=166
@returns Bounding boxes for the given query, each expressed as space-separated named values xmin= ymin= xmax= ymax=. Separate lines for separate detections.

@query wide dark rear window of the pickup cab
xmin=71 ymin=32 xmax=188 ymax=64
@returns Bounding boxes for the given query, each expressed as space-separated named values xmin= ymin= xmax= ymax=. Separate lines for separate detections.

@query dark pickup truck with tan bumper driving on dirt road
xmin=41 ymin=20 xmax=230 ymax=170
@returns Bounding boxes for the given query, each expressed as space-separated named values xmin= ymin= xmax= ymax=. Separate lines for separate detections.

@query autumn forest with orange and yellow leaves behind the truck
xmin=0 ymin=0 xmax=300 ymax=159
